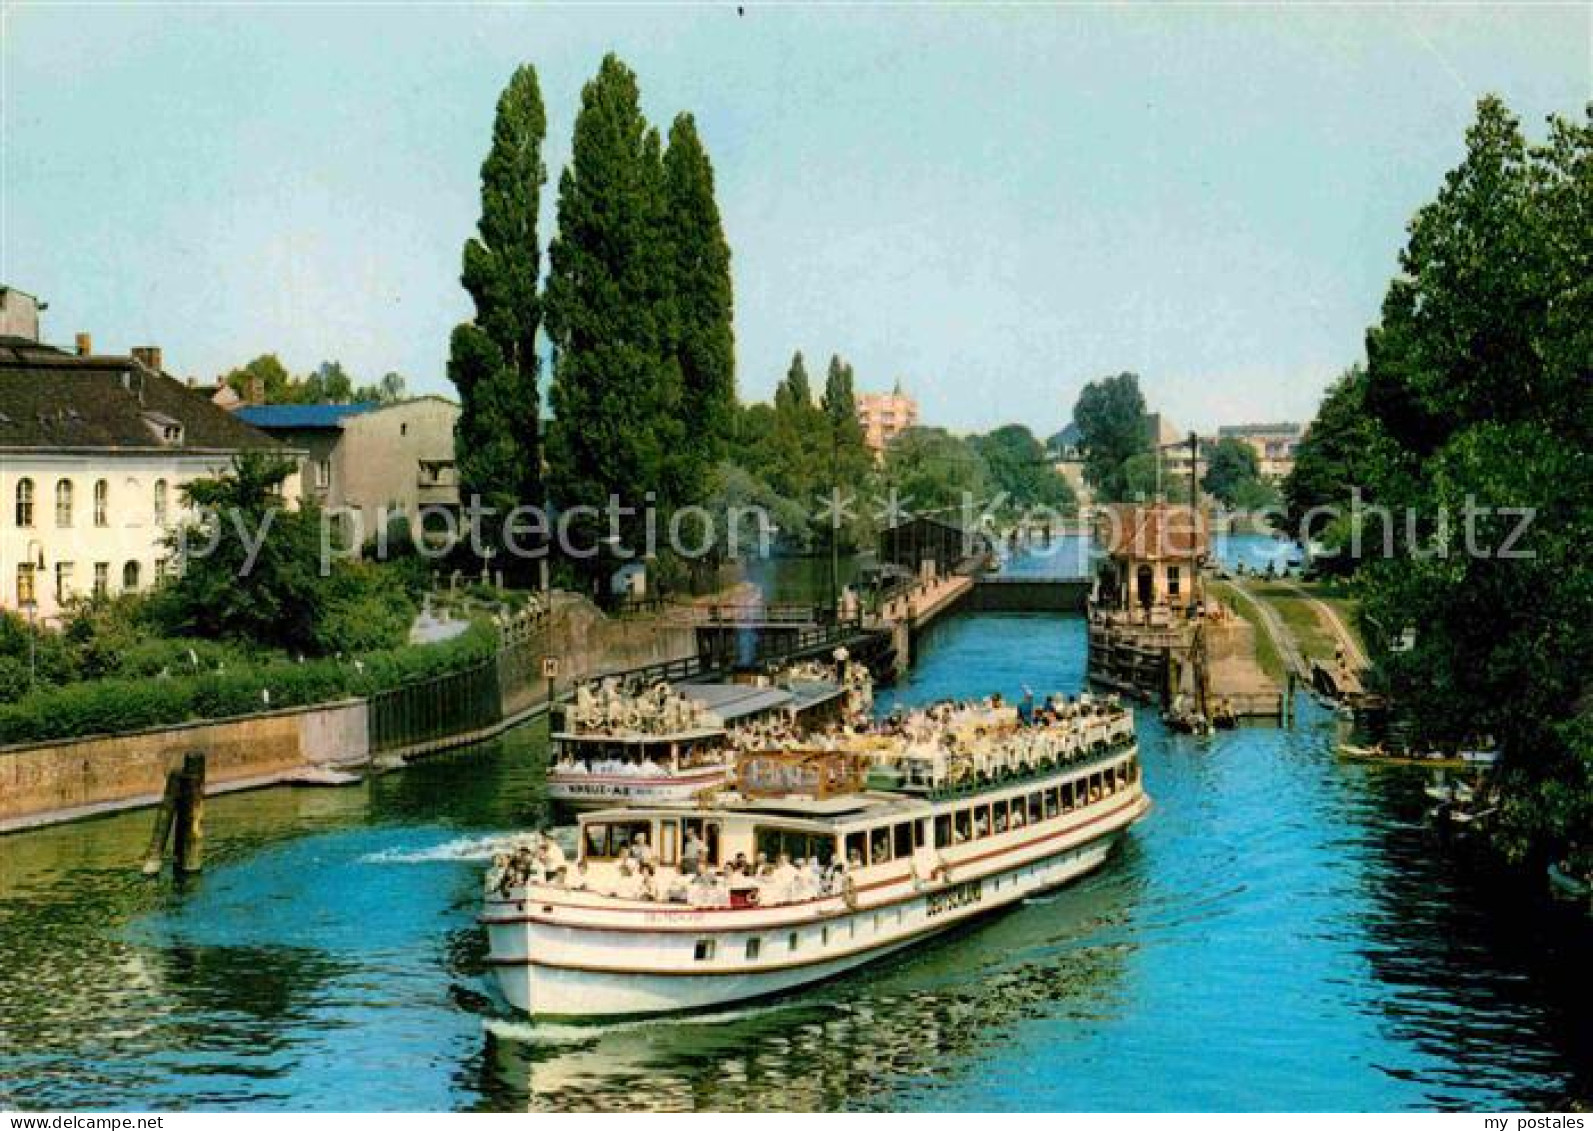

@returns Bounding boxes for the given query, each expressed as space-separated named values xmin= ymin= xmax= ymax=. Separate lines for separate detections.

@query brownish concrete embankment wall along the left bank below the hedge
xmin=0 ymin=594 xmax=696 ymax=833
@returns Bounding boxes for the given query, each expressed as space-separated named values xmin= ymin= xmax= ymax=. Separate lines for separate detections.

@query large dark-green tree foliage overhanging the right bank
xmin=1306 ymin=97 xmax=1593 ymax=855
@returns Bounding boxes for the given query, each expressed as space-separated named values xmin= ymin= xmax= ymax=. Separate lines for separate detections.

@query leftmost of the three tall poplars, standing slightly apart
xmin=448 ymin=65 xmax=546 ymax=560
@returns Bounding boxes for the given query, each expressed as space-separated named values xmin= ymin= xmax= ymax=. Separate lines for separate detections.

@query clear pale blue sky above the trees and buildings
xmin=0 ymin=0 xmax=1593 ymax=435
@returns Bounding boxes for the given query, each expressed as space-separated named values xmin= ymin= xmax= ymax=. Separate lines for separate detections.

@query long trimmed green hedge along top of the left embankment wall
xmin=0 ymin=623 xmax=497 ymax=746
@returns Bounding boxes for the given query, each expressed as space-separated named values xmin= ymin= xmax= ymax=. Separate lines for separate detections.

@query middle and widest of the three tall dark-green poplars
xmin=545 ymin=54 xmax=687 ymax=548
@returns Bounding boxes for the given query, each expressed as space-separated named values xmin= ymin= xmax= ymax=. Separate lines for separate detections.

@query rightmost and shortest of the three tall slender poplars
xmin=664 ymin=113 xmax=736 ymax=502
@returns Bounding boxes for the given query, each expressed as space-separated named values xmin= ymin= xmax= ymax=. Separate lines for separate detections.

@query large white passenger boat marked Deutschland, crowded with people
xmin=481 ymin=704 xmax=1150 ymax=1018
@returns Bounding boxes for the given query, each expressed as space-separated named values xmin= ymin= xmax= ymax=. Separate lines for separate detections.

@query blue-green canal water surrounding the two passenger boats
xmin=0 ymin=615 xmax=1593 ymax=1110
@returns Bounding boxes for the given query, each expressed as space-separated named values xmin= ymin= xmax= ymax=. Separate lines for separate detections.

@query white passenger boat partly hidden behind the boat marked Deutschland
xmin=546 ymin=655 xmax=871 ymax=809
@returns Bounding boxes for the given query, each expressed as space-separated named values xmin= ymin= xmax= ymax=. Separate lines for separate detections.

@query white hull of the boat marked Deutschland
xmin=484 ymin=792 xmax=1150 ymax=1018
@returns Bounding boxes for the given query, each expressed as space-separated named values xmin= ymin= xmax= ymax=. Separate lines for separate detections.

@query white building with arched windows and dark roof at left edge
xmin=0 ymin=305 xmax=298 ymax=620
